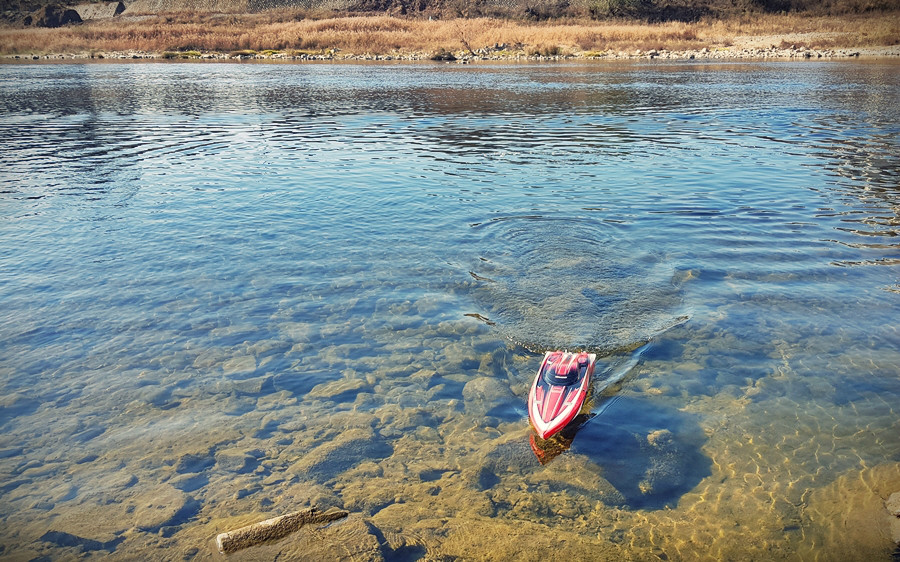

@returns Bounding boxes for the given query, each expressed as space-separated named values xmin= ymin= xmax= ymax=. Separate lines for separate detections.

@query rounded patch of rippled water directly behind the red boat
xmin=471 ymin=215 xmax=685 ymax=352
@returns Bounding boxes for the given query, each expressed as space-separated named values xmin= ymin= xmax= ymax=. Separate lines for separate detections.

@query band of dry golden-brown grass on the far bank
xmin=0 ymin=10 xmax=900 ymax=54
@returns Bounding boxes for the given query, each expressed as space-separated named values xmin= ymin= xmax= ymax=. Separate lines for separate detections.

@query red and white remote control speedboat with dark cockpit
xmin=528 ymin=351 xmax=597 ymax=439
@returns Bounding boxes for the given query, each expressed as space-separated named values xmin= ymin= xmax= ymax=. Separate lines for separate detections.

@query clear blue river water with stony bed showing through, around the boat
xmin=0 ymin=62 xmax=900 ymax=560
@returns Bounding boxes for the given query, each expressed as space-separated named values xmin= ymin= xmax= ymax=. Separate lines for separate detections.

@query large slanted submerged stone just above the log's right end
xmin=289 ymin=428 xmax=394 ymax=482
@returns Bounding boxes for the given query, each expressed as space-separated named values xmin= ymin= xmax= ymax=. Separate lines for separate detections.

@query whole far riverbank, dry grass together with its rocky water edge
xmin=0 ymin=13 xmax=900 ymax=62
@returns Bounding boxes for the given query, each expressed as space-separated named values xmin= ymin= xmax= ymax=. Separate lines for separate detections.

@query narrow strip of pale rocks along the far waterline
xmin=5 ymin=44 xmax=900 ymax=64
